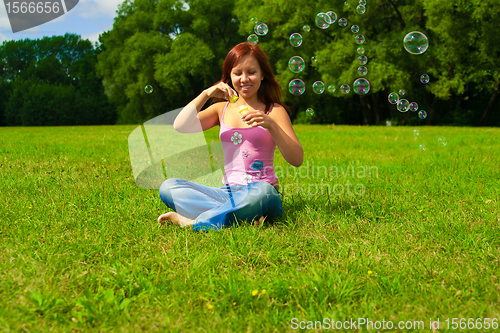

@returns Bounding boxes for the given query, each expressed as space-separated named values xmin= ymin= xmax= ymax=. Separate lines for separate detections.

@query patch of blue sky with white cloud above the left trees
xmin=0 ymin=0 xmax=124 ymax=45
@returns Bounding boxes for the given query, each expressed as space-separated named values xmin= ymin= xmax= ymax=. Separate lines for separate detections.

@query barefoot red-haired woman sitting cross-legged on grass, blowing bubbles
xmin=158 ymin=43 xmax=304 ymax=230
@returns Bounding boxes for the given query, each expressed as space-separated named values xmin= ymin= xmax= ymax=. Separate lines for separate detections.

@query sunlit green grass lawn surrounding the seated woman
xmin=0 ymin=125 xmax=500 ymax=332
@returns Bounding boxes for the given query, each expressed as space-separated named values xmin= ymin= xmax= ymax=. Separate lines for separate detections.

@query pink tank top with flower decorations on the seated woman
xmin=219 ymin=102 xmax=278 ymax=185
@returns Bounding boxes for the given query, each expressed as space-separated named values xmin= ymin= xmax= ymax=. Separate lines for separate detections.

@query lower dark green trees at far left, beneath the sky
xmin=0 ymin=34 xmax=116 ymax=126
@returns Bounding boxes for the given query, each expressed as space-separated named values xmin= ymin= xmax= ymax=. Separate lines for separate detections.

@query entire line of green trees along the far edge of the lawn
xmin=0 ymin=0 xmax=500 ymax=126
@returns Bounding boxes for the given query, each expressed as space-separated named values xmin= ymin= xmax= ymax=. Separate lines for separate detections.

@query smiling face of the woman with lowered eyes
xmin=231 ymin=54 xmax=264 ymax=99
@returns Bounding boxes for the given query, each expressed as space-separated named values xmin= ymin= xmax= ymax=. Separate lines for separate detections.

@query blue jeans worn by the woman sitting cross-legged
xmin=160 ymin=178 xmax=283 ymax=231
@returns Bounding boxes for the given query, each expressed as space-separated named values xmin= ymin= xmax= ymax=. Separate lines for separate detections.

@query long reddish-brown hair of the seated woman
xmin=221 ymin=42 xmax=288 ymax=112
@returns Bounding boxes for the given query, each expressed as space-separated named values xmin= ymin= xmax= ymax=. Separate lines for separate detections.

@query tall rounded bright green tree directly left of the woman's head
xmin=97 ymin=0 xmax=243 ymax=123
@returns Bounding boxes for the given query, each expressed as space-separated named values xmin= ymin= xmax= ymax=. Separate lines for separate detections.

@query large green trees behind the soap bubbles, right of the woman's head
xmin=236 ymin=0 xmax=499 ymax=124
